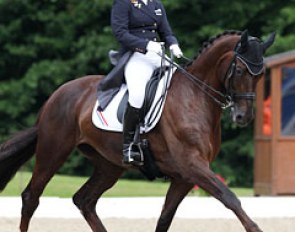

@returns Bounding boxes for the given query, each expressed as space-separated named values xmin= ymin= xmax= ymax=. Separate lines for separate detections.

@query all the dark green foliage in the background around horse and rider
xmin=0 ymin=0 xmax=295 ymax=186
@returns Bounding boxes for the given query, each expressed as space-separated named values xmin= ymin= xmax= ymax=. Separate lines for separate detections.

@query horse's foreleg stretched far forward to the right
xmin=188 ymin=161 xmax=261 ymax=232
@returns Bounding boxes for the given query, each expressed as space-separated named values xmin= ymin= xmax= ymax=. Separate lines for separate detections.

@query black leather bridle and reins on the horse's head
xmin=165 ymin=38 xmax=263 ymax=109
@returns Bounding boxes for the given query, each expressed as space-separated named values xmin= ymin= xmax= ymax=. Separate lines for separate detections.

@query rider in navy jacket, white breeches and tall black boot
xmin=111 ymin=0 xmax=182 ymax=164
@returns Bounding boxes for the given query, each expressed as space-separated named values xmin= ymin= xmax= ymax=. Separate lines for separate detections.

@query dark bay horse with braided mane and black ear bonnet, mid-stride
xmin=0 ymin=32 xmax=274 ymax=232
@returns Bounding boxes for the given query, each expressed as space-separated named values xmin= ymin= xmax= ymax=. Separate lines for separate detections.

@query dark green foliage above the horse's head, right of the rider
xmin=163 ymin=0 xmax=295 ymax=56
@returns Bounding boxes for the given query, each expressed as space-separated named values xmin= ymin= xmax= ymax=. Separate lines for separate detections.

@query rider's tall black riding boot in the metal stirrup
xmin=123 ymin=103 xmax=143 ymax=165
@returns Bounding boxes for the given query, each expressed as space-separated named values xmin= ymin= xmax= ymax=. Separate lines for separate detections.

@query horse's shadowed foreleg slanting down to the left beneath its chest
xmin=156 ymin=180 xmax=193 ymax=232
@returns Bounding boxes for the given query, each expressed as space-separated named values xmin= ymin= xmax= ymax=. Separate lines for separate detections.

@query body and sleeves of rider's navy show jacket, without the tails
xmin=111 ymin=0 xmax=178 ymax=53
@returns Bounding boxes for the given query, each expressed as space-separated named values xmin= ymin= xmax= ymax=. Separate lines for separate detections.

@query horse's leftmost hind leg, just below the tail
xmin=20 ymin=133 xmax=74 ymax=232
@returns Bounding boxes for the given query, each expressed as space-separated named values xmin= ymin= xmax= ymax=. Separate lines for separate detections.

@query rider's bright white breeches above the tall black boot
xmin=125 ymin=52 xmax=161 ymax=108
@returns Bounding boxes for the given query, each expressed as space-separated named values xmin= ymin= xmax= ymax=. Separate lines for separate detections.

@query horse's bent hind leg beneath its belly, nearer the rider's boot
xmin=73 ymin=147 xmax=123 ymax=232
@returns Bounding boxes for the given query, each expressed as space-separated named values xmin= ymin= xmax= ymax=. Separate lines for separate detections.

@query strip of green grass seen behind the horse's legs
xmin=0 ymin=172 xmax=253 ymax=198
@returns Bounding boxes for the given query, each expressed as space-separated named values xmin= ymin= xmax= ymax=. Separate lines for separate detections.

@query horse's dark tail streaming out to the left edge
xmin=0 ymin=127 xmax=37 ymax=192
